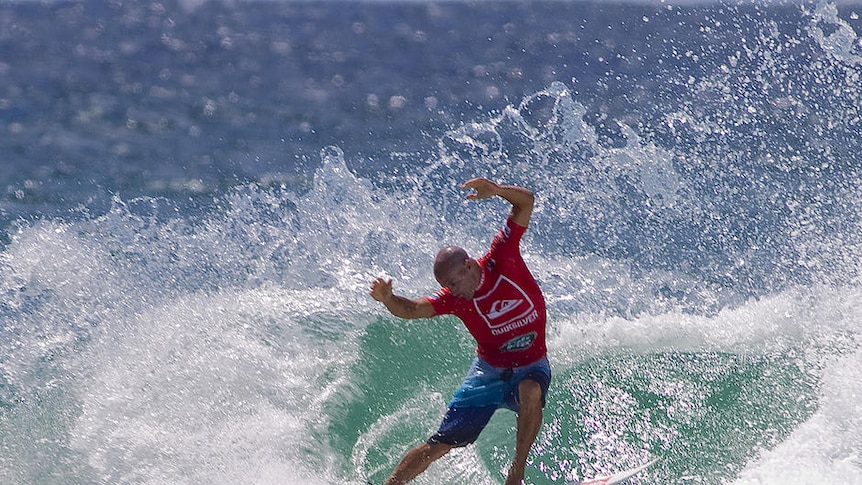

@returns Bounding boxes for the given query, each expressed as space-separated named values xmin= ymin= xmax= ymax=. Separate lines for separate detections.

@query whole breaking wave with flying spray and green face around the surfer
xmin=0 ymin=4 xmax=862 ymax=484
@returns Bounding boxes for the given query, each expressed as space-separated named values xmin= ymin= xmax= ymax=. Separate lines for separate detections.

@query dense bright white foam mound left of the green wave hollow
xmin=70 ymin=289 xmax=358 ymax=484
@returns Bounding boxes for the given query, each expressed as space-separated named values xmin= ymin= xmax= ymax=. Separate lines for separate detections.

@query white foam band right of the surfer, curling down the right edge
xmin=549 ymin=287 xmax=862 ymax=485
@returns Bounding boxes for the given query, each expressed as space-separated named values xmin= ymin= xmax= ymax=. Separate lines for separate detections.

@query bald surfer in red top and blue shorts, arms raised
xmin=371 ymin=178 xmax=551 ymax=485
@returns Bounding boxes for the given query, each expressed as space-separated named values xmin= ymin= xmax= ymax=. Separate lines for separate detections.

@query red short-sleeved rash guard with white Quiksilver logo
xmin=427 ymin=219 xmax=547 ymax=367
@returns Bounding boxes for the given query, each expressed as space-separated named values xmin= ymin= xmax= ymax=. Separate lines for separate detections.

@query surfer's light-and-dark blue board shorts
xmin=428 ymin=357 xmax=551 ymax=447
